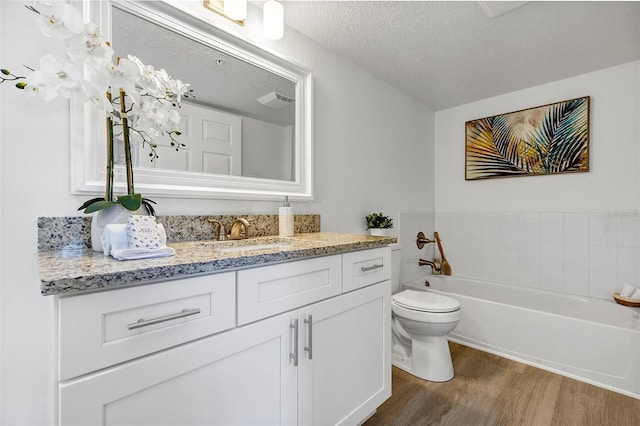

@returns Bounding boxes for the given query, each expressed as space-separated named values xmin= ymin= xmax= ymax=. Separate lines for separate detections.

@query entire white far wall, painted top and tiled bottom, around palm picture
xmin=435 ymin=62 xmax=640 ymax=300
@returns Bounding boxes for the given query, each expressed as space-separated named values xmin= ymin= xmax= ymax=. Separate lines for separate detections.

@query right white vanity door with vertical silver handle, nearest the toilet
xmin=298 ymin=281 xmax=391 ymax=425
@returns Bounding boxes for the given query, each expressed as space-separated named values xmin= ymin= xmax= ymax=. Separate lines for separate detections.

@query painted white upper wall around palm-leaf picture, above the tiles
xmin=435 ymin=62 xmax=640 ymax=212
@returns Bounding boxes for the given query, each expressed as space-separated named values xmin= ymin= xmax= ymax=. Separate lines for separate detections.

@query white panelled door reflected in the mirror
xmin=138 ymin=102 xmax=242 ymax=176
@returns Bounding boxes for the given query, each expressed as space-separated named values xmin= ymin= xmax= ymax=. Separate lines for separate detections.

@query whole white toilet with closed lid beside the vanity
xmin=391 ymin=245 xmax=461 ymax=382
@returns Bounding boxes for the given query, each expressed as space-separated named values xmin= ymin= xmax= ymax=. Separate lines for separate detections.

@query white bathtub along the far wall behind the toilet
xmin=403 ymin=275 xmax=640 ymax=399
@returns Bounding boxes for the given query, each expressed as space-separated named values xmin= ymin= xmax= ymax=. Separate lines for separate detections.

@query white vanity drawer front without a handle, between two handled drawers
xmin=237 ymin=255 xmax=342 ymax=325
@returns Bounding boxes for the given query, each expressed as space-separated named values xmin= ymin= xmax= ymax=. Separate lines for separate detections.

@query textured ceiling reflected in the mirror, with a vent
xmin=112 ymin=7 xmax=295 ymax=126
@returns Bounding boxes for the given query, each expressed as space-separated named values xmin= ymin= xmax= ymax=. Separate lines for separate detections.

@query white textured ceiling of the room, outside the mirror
xmin=282 ymin=0 xmax=640 ymax=111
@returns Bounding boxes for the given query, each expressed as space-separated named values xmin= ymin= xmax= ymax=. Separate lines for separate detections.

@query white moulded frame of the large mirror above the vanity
xmin=70 ymin=0 xmax=313 ymax=200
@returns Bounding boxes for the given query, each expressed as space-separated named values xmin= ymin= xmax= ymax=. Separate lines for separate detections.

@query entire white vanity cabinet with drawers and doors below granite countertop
xmin=58 ymin=248 xmax=391 ymax=425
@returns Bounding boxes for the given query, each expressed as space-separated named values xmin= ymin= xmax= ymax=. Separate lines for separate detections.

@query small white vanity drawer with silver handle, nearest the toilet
xmin=342 ymin=247 xmax=391 ymax=292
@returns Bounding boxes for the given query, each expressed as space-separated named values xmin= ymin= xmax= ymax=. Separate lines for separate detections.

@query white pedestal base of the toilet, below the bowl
xmin=391 ymin=336 xmax=454 ymax=382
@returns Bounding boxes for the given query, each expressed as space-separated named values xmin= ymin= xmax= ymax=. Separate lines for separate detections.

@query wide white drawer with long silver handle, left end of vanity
xmin=58 ymin=272 xmax=235 ymax=380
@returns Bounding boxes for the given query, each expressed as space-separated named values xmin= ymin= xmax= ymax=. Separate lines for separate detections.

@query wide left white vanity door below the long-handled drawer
xmin=59 ymin=314 xmax=297 ymax=425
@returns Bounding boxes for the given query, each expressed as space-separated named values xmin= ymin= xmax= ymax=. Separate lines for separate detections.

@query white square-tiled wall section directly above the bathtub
xmin=436 ymin=211 xmax=640 ymax=299
